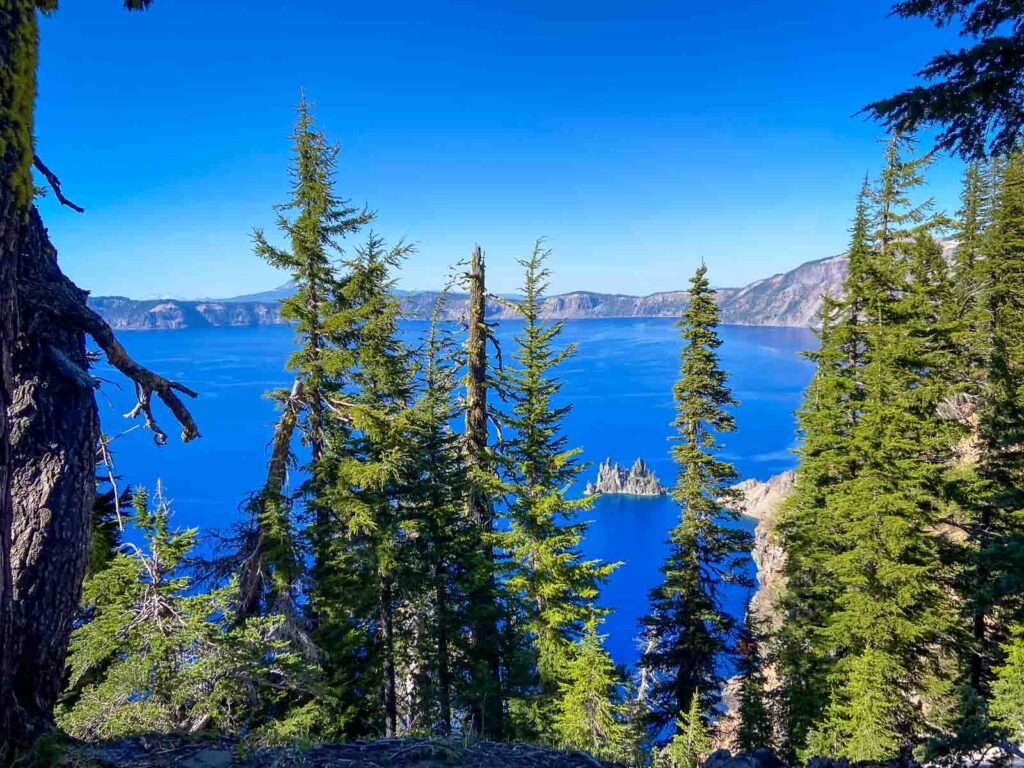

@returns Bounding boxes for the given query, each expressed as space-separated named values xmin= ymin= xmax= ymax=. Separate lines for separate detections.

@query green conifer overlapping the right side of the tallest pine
xmin=310 ymin=234 xmax=416 ymax=736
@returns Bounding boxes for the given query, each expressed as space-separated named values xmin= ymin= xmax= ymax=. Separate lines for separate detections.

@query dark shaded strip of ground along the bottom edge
xmin=71 ymin=736 xmax=608 ymax=768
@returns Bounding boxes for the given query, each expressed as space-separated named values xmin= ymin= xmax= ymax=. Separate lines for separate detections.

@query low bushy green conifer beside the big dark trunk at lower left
xmin=57 ymin=486 xmax=314 ymax=739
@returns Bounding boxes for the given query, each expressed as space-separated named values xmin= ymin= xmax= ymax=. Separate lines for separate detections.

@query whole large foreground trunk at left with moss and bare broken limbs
xmin=0 ymin=0 xmax=199 ymax=760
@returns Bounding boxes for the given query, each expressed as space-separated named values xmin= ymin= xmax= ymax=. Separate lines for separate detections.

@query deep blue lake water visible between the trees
xmin=97 ymin=318 xmax=816 ymax=664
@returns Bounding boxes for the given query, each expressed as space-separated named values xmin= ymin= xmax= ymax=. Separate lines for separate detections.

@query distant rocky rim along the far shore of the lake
xmin=89 ymin=242 xmax=955 ymax=330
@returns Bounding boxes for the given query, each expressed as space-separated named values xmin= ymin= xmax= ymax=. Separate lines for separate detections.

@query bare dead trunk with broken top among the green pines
xmin=465 ymin=246 xmax=505 ymax=740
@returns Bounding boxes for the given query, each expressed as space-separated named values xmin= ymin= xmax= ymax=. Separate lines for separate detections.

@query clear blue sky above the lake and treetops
xmin=36 ymin=0 xmax=962 ymax=297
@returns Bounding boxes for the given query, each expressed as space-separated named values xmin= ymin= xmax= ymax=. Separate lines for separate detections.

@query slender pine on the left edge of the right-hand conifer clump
xmin=775 ymin=192 xmax=872 ymax=760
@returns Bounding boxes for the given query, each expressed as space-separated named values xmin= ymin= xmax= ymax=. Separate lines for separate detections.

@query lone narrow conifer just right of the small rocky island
xmin=640 ymin=266 xmax=753 ymax=730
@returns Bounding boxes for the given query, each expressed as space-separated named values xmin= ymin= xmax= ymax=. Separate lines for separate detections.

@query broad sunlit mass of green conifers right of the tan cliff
xmin=776 ymin=137 xmax=982 ymax=760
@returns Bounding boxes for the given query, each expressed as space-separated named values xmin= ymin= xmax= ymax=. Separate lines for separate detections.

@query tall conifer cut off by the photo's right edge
xmin=957 ymin=155 xmax=1024 ymax=712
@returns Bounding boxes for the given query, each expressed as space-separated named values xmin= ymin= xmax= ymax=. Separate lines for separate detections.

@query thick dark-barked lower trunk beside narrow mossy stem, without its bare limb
xmin=9 ymin=210 xmax=99 ymax=725
